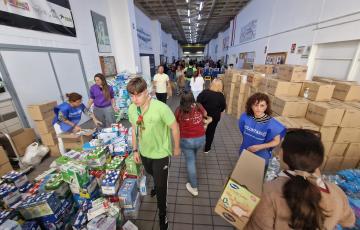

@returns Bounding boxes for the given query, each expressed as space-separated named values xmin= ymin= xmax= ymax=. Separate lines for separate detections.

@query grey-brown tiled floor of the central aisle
xmin=135 ymin=95 xmax=241 ymax=230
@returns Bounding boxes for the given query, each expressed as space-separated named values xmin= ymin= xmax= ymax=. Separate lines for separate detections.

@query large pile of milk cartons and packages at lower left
xmin=0 ymin=124 xmax=147 ymax=230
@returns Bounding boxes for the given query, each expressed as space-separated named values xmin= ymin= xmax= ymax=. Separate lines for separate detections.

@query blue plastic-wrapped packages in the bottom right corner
xmin=324 ymin=169 xmax=360 ymax=229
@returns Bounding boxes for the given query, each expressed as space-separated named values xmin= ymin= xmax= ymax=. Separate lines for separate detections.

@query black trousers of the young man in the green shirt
xmin=141 ymin=156 xmax=170 ymax=216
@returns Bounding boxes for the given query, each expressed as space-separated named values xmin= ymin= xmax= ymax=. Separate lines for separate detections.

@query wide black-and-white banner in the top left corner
xmin=0 ymin=0 xmax=76 ymax=37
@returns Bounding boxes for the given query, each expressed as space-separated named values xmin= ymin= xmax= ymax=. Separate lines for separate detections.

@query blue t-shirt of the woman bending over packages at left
xmin=53 ymin=102 xmax=86 ymax=132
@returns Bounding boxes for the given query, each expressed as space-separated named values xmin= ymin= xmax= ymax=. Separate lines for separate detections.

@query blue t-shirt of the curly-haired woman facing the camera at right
xmin=239 ymin=113 xmax=286 ymax=165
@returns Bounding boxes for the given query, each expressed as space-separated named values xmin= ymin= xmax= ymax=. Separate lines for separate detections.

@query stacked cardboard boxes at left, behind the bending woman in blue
xmin=28 ymin=101 xmax=60 ymax=157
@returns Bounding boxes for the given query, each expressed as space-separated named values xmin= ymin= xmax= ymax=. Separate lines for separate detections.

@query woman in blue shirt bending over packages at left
xmin=53 ymin=93 xmax=102 ymax=154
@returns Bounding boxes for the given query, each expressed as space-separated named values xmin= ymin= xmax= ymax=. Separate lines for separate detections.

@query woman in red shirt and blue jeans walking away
xmin=175 ymin=92 xmax=207 ymax=196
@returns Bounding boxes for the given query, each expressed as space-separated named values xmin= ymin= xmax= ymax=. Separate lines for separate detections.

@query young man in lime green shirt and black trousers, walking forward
xmin=127 ymin=77 xmax=180 ymax=230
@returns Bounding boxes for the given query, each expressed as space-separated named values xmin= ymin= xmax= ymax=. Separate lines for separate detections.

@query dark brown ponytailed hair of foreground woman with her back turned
xmin=281 ymin=129 xmax=327 ymax=230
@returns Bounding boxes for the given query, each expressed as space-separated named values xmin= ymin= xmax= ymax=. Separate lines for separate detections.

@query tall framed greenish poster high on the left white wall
xmin=91 ymin=11 xmax=111 ymax=53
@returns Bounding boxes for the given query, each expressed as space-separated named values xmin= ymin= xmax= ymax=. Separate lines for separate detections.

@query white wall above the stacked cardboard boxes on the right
xmin=208 ymin=0 xmax=360 ymax=80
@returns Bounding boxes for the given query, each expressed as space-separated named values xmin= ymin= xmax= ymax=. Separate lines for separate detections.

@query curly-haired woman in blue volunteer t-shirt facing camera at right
xmin=239 ymin=93 xmax=286 ymax=167
